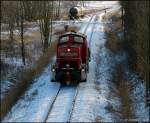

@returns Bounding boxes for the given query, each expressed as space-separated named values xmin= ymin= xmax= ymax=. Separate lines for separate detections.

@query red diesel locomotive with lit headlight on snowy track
xmin=51 ymin=32 xmax=90 ymax=82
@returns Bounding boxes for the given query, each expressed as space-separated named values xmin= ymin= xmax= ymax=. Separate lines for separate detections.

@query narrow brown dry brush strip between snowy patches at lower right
xmin=112 ymin=65 xmax=134 ymax=120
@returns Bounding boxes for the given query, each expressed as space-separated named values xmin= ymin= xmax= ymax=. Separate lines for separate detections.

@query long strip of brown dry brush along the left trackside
xmin=0 ymin=41 xmax=56 ymax=119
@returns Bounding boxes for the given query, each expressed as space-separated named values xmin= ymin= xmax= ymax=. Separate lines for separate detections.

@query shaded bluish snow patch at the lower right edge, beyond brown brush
xmin=126 ymin=70 xmax=150 ymax=122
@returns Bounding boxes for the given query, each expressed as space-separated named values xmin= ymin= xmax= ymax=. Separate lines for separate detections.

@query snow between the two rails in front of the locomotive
xmin=46 ymin=86 xmax=76 ymax=122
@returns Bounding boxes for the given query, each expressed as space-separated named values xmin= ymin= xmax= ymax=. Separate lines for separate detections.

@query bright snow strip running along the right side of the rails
xmin=71 ymin=13 xmax=119 ymax=122
